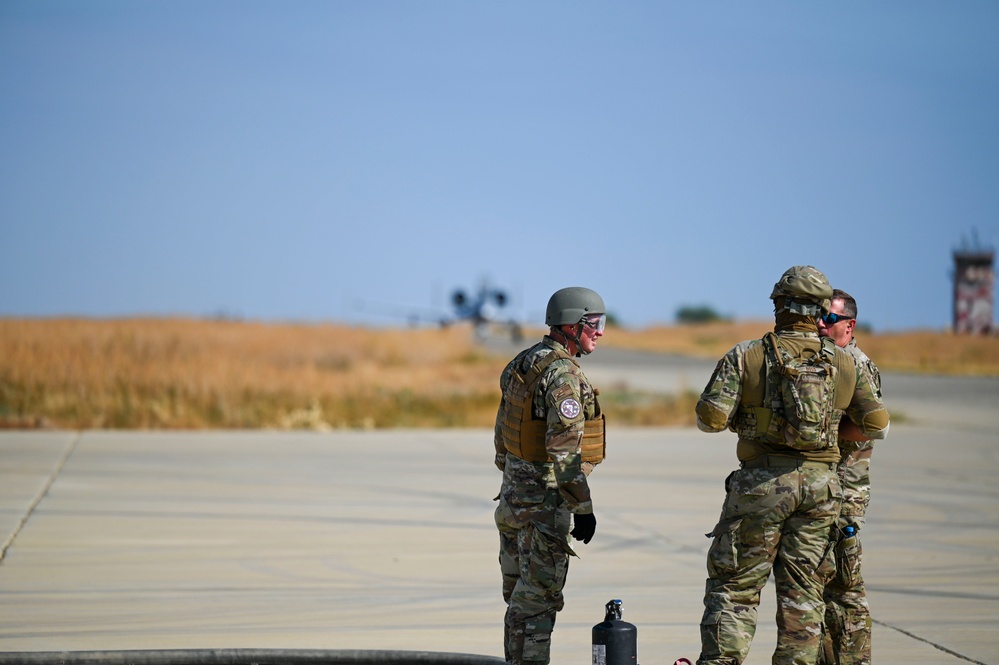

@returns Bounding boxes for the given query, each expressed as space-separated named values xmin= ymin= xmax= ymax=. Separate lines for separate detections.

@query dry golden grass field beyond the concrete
xmin=0 ymin=319 xmax=999 ymax=430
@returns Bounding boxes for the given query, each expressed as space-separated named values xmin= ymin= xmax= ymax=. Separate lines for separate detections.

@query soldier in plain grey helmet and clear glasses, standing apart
xmin=494 ymin=286 xmax=607 ymax=665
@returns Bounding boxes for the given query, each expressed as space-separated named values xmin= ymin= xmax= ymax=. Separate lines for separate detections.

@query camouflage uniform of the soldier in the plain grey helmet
xmin=494 ymin=336 xmax=599 ymax=665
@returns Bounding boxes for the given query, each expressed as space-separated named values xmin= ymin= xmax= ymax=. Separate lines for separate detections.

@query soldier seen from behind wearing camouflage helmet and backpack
xmin=696 ymin=266 xmax=889 ymax=665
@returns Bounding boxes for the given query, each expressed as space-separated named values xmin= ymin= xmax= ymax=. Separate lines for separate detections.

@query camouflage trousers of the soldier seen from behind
xmin=697 ymin=456 xmax=842 ymax=665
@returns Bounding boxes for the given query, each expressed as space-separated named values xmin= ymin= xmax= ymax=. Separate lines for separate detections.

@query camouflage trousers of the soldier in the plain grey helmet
xmin=495 ymin=472 xmax=573 ymax=665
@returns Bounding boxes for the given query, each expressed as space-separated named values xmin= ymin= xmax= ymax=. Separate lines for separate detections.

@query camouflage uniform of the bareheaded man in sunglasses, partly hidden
xmin=819 ymin=339 xmax=881 ymax=665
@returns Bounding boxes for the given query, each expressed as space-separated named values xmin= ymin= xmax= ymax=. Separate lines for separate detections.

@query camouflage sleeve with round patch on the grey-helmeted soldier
xmin=535 ymin=360 xmax=593 ymax=513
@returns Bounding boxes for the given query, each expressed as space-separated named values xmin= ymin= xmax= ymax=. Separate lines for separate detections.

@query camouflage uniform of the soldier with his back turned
xmin=696 ymin=326 xmax=888 ymax=665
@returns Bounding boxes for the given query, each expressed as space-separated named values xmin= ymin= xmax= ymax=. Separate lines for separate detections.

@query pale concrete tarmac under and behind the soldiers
xmin=0 ymin=354 xmax=999 ymax=665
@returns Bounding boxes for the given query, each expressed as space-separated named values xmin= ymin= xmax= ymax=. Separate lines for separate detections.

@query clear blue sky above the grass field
xmin=0 ymin=0 xmax=999 ymax=331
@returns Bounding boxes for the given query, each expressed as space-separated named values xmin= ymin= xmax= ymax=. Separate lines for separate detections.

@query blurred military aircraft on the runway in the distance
xmin=358 ymin=280 xmax=524 ymax=342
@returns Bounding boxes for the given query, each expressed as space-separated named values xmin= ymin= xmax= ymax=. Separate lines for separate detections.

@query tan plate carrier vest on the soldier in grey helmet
xmin=502 ymin=349 xmax=607 ymax=464
